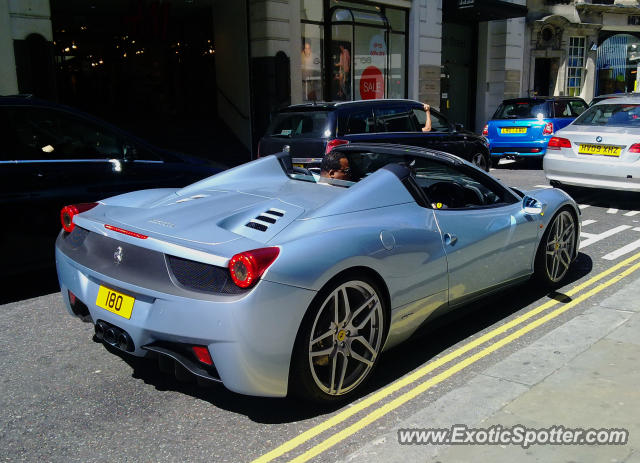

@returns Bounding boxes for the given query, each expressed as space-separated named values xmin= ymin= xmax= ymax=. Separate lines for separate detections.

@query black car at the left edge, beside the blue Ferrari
xmin=0 ymin=96 xmax=220 ymax=275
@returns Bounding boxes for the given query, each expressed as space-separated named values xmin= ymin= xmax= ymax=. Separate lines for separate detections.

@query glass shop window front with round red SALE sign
xmin=300 ymin=0 xmax=408 ymax=101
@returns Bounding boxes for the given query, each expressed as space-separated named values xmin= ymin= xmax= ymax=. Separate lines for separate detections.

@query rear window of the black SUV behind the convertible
xmin=266 ymin=111 xmax=331 ymax=138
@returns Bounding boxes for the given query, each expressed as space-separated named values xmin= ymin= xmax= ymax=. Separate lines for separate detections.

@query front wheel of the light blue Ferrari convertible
xmin=534 ymin=208 xmax=578 ymax=288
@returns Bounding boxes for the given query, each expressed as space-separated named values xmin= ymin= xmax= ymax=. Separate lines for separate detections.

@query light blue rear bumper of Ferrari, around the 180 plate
xmin=56 ymin=246 xmax=316 ymax=397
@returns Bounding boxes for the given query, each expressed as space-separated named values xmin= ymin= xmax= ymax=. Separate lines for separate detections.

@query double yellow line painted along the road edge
xmin=252 ymin=253 xmax=640 ymax=463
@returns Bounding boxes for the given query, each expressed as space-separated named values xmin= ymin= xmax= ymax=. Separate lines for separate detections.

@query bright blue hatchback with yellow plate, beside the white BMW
xmin=482 ymin=97 xmax=587 ymax=165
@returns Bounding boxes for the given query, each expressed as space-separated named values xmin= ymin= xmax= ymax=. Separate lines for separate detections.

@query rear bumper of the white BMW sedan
xmin=543 ymin=152 xmax=640 ymax=192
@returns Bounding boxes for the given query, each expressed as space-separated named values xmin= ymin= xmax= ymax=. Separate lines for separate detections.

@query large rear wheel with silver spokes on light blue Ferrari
xmin=289 ymin=273 xmax=389 ymax=403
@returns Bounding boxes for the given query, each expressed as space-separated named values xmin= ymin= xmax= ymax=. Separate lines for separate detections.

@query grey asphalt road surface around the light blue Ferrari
xmin=0 ymin=164 xmax=640 ymax=462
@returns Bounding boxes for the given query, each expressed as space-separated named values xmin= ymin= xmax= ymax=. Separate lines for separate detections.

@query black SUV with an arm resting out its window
xmin=258 ymin=100 xmax=490 ymax=171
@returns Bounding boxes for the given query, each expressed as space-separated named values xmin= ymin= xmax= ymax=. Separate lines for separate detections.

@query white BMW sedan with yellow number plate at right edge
xmin=543 ymin=98 xmax=640 ymax=191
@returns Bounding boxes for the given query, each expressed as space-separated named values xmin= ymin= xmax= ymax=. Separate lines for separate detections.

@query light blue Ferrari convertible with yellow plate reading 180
xmin=56 ymin=144 xmax=580 ymax=401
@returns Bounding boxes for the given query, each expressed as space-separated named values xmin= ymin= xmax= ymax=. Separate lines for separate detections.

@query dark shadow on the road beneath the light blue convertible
xmin=109 ymin=253 xmax=592 ymax=424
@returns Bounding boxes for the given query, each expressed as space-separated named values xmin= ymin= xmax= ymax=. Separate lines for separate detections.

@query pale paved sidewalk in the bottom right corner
xmin=341 ymin=279 xmax=640 ymax=463
